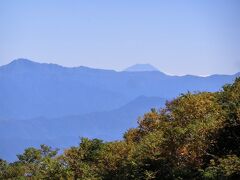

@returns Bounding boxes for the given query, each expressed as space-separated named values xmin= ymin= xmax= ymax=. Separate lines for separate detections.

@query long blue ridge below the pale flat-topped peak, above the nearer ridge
xmin=0 ymin=59 xmax=237 ymax=118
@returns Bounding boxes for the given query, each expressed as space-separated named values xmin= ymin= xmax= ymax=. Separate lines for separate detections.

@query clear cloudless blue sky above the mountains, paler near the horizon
xmin=0 ymin=0 xmax=240 ymax=75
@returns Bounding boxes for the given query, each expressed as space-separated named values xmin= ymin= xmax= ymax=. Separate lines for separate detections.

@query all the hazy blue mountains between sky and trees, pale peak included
xmin=0 ymin=59 xmax=240 ymax=160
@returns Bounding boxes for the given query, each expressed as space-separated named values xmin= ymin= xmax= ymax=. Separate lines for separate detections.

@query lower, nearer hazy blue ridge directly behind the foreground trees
xmin=0 ymin=96 xmax=165 ymax=161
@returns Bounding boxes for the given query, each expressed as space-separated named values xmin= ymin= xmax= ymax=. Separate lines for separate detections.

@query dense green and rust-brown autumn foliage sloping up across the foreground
xmin=0 ymin=78 xmax=240 ymax=180
